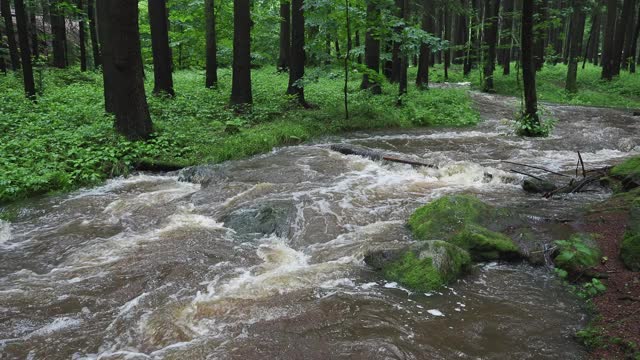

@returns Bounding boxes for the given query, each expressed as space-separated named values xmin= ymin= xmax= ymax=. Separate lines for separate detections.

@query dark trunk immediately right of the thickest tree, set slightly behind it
xmin=149 ymin=0 xmax=175 ymax=96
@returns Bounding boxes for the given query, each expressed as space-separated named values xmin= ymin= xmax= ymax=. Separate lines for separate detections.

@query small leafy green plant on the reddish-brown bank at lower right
xmin=554 ymin=234 xmax=601 ymax=273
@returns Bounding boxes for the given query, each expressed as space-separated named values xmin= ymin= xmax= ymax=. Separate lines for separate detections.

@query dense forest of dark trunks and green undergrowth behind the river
xmin=0 ymin=0 xmax=640 ymax=201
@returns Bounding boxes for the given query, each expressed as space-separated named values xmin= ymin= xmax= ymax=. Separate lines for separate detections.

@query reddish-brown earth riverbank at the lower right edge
xmin=577 ymin=158 xmax=640 ymax=359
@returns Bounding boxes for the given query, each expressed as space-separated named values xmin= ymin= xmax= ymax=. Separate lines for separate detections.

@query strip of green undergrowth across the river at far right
xmin=424 ymin=63 xmax=640 ymax=109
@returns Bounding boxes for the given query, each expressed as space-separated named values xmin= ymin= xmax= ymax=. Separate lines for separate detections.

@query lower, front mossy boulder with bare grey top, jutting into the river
xmin=365 ymin=240 xmax=471 ymax=291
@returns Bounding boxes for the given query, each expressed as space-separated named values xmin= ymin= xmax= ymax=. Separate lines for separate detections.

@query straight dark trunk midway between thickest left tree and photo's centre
xmin=231 ymin=0 xmax=253 ymax=110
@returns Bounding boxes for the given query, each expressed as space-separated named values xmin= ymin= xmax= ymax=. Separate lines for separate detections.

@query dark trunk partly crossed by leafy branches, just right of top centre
xmin=360 ymin=0 xmax=382 ymax=95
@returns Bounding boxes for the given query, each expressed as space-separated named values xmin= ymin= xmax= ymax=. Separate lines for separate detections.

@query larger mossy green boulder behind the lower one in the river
xmin=409 ymin=195 xmax=520 ymax=261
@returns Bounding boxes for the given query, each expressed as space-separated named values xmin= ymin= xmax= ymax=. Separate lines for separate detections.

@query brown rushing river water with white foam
xmin=0 ymin=94 xmax=640 ymax=360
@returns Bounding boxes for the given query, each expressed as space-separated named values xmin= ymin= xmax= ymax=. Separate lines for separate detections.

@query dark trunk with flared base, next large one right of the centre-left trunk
xmin=287 ymin=0 xmax=309 ymax=108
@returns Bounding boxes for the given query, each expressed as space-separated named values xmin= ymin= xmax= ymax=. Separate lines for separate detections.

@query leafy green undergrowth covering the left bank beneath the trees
xmin=0 ymin=69 xmax=479 ymax=203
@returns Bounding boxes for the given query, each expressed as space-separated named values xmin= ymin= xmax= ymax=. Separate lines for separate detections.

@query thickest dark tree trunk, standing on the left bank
xmin=98 ymin=0 xmax=153 ymax=140
